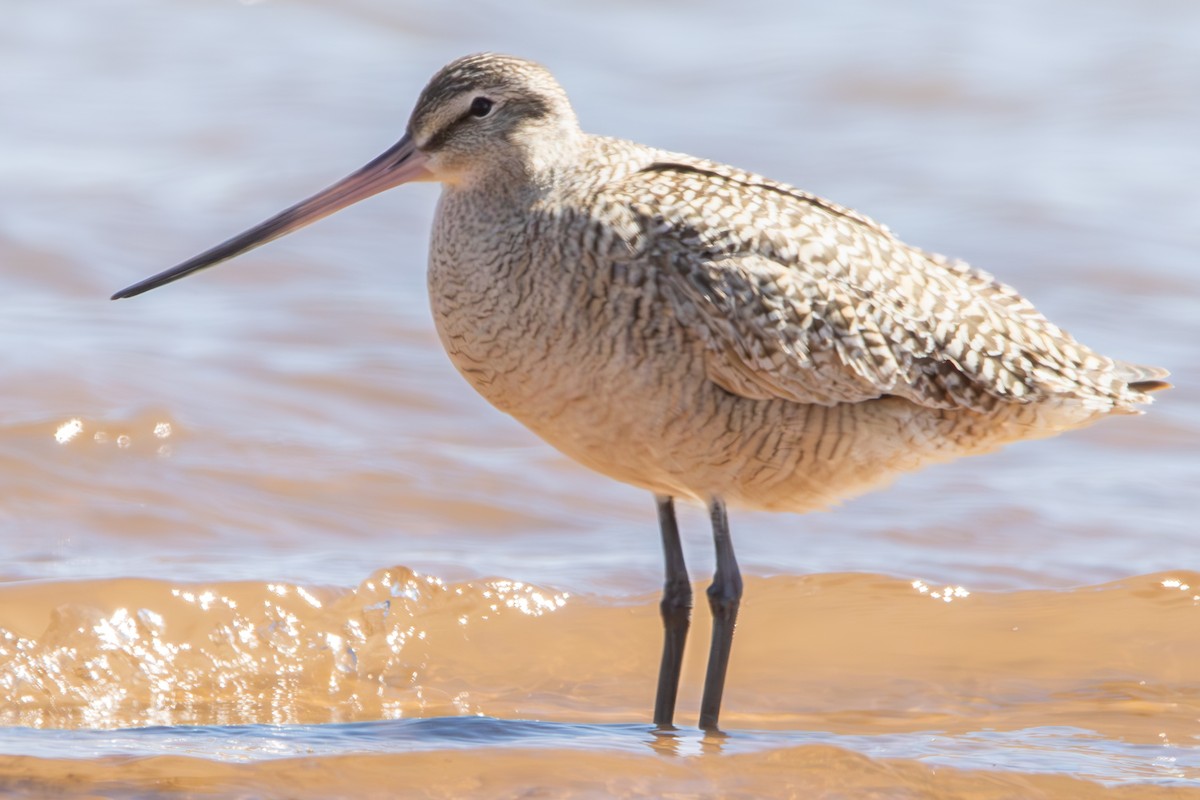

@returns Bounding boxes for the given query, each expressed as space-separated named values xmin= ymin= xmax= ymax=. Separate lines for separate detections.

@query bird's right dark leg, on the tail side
xmin=700 ymin=499 xmax=742 ymax=730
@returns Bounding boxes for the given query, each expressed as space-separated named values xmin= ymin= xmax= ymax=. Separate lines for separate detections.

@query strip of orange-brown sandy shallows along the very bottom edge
xmin=0 ymin=746 xmax=1200 ymax=800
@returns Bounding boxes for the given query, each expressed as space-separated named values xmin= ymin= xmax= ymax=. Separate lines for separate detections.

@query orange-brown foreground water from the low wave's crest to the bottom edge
xmin=0 ymin=567 xmax=1200 ymax=798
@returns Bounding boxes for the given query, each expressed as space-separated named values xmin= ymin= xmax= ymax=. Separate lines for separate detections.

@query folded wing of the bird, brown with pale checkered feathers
xmin=605 ymin=161 xmax=1136 ymax=410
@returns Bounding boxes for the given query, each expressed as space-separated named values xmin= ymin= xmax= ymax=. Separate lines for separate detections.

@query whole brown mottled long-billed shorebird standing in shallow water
xmin=113 ymin=53 xmax=1170 ymax=733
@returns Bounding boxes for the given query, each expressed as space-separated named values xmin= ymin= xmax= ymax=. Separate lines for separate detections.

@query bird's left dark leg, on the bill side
xmin=654 ymin=494 xmax=691 ymax=728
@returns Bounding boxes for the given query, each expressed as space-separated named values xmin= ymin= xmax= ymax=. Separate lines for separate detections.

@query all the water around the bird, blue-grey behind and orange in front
xmin=0 ymin=0 xmax=1200 ymax=798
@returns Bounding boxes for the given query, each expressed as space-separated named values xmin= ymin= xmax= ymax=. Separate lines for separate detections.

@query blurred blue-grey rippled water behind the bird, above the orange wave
xmin=0 ymin=0 xmax=1200 ymax=796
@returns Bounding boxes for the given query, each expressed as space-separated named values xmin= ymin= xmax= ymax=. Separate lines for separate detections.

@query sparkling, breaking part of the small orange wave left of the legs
xmin=0 ymin=567 xmax=568 ymax=728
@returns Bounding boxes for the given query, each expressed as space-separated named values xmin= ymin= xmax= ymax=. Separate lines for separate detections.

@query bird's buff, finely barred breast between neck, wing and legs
xmin=428 ymin=190 xmax=708 ymax=486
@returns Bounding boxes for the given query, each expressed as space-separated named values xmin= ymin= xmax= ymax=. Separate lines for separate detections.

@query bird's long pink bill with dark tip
xmin=113 ymin=136 xmax=432 ymax=300
